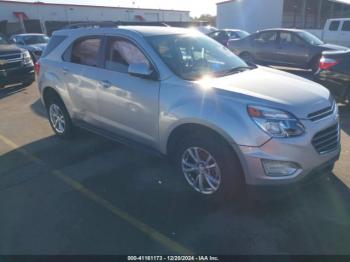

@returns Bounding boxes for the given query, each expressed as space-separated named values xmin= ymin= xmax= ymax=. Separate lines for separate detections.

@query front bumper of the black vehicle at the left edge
xmin=0 ymin=65 xmax=35 ymax=85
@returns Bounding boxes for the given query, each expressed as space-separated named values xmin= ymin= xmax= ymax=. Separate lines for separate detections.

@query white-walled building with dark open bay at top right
xmin=216 ymin=0 xmax=350 ymax=32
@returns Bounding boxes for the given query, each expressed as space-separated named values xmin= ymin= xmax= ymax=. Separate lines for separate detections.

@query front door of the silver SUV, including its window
xmin=95 ymin=37 xmax=160 ymax=145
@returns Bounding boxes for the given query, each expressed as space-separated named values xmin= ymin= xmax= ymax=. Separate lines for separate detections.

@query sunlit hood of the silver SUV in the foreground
xmin=198 ymin=67 xmax=333 ymax=119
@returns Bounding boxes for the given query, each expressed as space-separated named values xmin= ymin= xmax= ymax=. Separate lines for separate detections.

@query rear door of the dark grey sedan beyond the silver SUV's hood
xmin=251 ymin=31 xmax=278 ymax=63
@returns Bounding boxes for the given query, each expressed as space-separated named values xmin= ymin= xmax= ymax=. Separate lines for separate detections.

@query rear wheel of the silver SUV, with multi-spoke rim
xmin=46 ymin=97 xmax=73 ymax=139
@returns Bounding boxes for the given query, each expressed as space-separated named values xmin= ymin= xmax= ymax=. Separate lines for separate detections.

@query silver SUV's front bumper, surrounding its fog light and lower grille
xmin=240 ymin=115 xmax=340 ymax=185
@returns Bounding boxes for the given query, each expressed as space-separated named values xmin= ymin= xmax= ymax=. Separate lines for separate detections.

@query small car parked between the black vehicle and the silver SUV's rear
xmin=11 ymin=34 xmax=49 ymax=63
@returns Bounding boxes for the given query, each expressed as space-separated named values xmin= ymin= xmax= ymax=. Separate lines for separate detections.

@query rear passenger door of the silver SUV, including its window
xmin=59 ymin=35 xmax=103 ymax=124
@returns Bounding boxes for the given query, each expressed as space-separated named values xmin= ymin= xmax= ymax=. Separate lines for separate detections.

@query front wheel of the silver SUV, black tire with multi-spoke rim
xmin=173 ymin=132 xmax=245 ymax=201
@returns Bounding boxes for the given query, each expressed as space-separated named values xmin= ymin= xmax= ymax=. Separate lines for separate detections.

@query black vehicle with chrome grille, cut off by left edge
xmin=0 ymin=34 xmax=34 ymax=87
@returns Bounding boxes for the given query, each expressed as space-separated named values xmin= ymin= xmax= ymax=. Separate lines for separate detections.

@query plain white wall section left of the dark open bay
xmin=216 ymin=0 xmax=283 ymax=33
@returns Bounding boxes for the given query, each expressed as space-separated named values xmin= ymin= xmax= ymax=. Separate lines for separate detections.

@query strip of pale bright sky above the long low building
xmin=6 ymin=0 xmax=220 ymax=16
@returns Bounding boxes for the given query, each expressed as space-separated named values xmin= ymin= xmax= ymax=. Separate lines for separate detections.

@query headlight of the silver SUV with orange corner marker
xmin=248 ymin=106 xmax=305 ymax=137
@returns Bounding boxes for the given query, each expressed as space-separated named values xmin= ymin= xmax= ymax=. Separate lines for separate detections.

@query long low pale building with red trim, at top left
xmin=0 ymin=0 xmax=191 ymax=35
